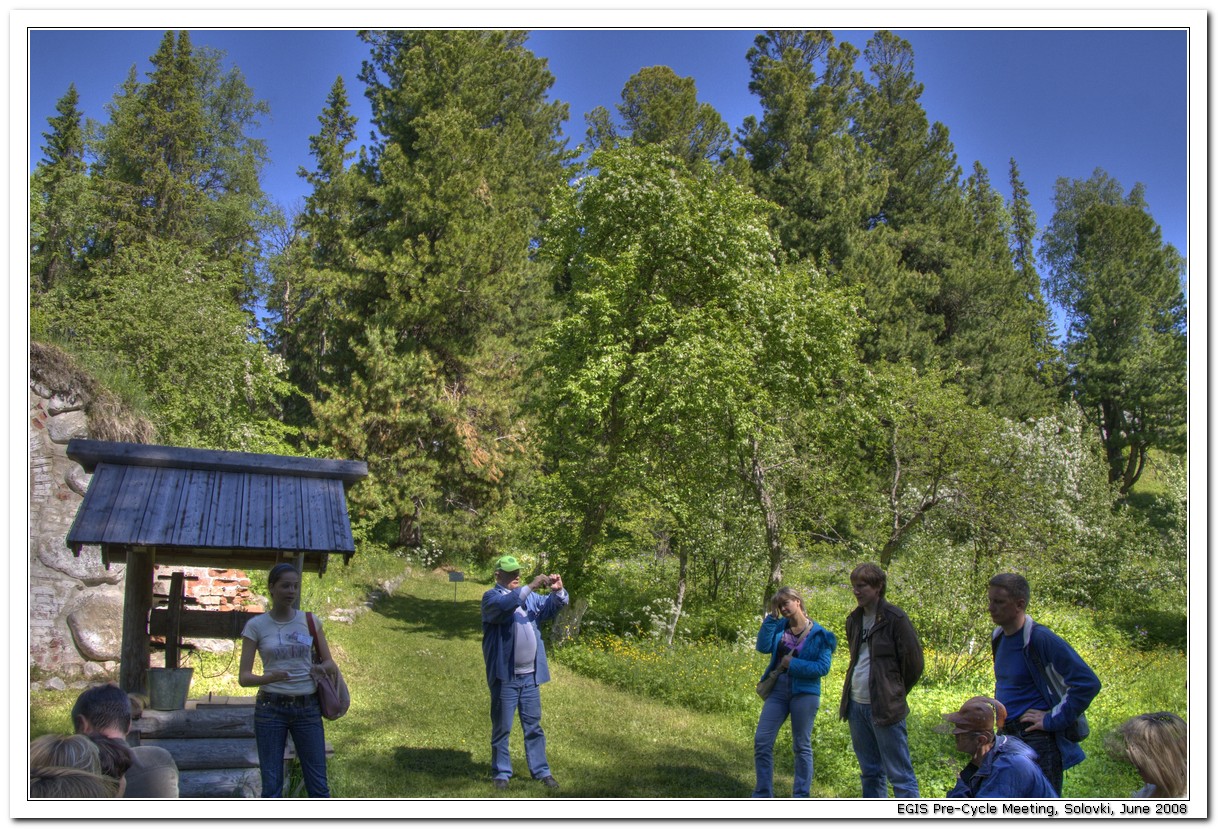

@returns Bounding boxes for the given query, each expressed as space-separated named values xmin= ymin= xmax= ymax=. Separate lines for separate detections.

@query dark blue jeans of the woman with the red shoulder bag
xmin=253 ymin=693 xmax=330 ymax=797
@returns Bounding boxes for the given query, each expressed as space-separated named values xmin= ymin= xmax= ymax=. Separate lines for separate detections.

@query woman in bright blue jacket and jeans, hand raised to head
xmin=753 ymin=587 xmax=837 ymax=797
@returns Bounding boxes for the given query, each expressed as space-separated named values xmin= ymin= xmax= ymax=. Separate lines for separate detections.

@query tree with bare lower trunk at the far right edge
xmin=1041 ymin=169 xmax=1188 ymax=493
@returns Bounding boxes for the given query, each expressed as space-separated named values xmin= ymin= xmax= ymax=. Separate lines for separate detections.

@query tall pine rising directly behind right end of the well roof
xmin=304 ymin=30 xmax=566 ymax=554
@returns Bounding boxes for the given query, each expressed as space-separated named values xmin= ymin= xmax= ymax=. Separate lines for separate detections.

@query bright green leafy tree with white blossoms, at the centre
xmin=543 ymin=147 xmax=856 ymax=590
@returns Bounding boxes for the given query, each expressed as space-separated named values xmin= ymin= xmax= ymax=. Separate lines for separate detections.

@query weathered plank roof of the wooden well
xmin=66 ymin=439 xmax=368 ymax=572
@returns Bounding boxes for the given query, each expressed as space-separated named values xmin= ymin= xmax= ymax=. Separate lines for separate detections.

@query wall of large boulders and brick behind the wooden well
xmin=28 ymin=367 xmax=262 ymax=688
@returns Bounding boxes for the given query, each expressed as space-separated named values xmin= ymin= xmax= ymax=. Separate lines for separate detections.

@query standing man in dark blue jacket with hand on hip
xmin=988 ymin=573 xmax=1100 ymax=795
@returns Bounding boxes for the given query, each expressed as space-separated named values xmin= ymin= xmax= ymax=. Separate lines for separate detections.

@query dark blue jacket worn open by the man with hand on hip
xmin=990 ymin=616 xmax=1100 ymax=771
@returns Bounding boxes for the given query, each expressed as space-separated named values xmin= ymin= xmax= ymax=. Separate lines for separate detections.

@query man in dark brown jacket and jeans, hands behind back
xmin=838 ymin=564 xmax=922 ymax=797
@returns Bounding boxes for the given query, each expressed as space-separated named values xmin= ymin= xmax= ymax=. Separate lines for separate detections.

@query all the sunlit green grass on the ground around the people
xmin=30 ymin=573 xmax=1188 ymax=799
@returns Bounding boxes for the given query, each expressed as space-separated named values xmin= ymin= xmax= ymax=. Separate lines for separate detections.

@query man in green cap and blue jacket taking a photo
xmin=482 ymin=555 xmax=569 ymax=789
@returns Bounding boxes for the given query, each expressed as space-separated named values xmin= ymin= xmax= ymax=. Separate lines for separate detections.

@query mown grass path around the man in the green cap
xmin=326 ymin=578 xmax=760 ymax=797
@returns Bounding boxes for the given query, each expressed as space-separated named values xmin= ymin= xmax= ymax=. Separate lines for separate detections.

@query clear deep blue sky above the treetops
xmin=28 ymin=27 xmax=1196 ymax=281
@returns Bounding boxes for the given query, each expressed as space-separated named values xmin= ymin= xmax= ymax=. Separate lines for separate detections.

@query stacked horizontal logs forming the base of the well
xmin=127 ymin=696 xmax=334 ymax=797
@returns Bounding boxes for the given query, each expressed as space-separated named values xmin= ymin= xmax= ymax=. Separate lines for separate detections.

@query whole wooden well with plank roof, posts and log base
xmin=66 ymin=439 xmax=368 ymax=797
